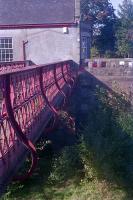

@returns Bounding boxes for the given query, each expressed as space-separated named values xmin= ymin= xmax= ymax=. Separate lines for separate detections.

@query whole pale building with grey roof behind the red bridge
xmin=0 ymin=0 xmax=90 ymax=64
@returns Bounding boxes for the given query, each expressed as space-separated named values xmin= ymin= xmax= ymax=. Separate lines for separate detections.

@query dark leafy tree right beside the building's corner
xmin=81 ymin=0 xmax=116 ymax=56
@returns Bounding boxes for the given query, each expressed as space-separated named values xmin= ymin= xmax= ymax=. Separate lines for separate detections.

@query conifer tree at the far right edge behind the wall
xmin=117 ymin=0 xmax=133 ymax=57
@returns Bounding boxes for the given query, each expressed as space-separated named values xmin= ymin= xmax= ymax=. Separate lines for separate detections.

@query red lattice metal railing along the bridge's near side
xmin=0 ymin=61 xmax=76 ymax=164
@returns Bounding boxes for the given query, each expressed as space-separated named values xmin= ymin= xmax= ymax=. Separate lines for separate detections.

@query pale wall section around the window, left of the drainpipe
xmin=0 ymin=29 xmax=26 ymax=61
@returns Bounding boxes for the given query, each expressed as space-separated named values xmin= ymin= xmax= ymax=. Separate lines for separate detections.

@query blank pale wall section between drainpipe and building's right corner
xmin=26 ymin=27 xmax=80 ymax=64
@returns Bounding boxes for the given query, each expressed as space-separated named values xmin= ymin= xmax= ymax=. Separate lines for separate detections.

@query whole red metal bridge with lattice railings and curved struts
xmin=0 ymin=61 xmax=78 ymax=192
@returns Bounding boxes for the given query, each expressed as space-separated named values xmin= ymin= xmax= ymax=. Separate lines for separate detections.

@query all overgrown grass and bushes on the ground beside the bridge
xmin=2 ymin=80 xmax=133 ymax=200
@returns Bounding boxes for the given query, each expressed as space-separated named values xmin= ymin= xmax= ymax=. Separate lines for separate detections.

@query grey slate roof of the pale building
xmin=0 ymin=0 xmax=75 ymax=26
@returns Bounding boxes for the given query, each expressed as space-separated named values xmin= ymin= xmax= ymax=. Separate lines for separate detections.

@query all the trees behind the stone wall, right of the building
xmin=81 ymin=0 xmax=133 ymax=58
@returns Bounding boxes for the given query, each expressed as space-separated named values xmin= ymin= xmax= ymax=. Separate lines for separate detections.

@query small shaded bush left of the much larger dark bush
xmin=49 ymin=145 xmax=83 ymax=184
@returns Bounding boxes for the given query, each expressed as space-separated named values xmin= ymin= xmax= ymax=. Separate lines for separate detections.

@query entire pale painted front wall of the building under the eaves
xmin=0 ymin=27 xmax=80 ymax=64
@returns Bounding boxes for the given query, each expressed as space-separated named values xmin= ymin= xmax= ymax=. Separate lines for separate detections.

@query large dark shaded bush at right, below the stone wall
xmin=81 ymin=88 xmax=133 ymax=186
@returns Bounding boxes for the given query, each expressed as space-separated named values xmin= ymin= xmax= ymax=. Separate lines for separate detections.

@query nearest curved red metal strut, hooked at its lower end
xmin=4 ymin=75 xmax=38 ymax=181
